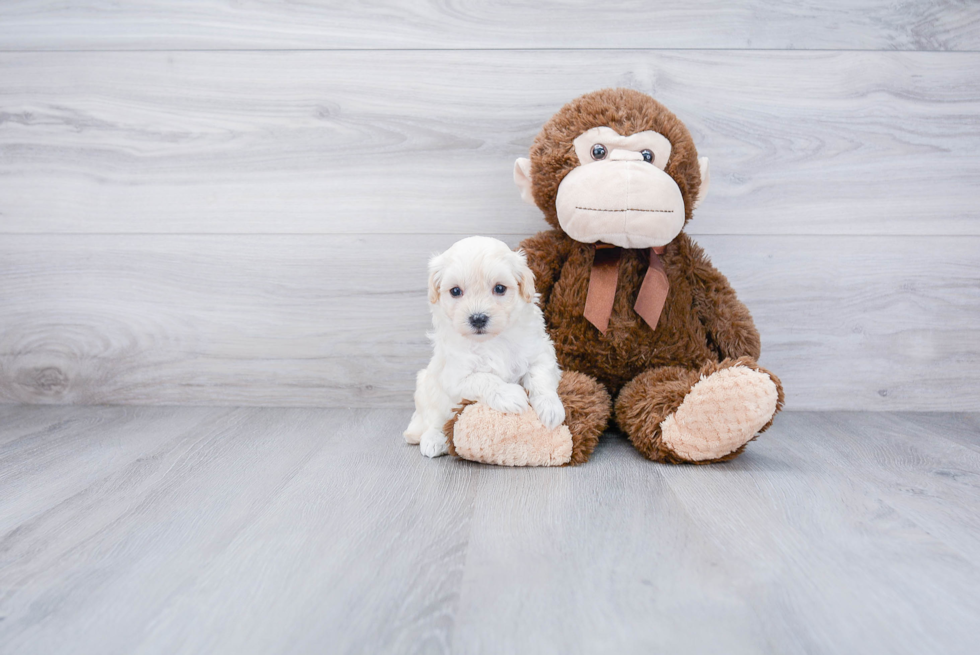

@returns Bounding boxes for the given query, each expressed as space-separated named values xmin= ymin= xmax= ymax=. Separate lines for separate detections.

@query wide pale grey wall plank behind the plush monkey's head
xmin=0 ymin=51 xmax=980 ymax=235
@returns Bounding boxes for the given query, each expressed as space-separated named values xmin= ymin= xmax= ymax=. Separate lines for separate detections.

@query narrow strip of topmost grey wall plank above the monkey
xmin=0 ymin=0 xmax=980 ymax=50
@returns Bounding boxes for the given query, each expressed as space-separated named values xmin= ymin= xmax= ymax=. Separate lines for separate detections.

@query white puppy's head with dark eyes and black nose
xmin=429 ymin=237 xmax=534 ymax=340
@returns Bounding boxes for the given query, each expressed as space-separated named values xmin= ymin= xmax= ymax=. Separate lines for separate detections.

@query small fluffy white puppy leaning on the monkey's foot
xmin=405 ymin=237 xmax=565 ymax=457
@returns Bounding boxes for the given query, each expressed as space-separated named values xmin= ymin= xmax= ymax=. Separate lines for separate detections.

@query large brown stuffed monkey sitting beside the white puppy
xmin=447 ymin=89 xmax=783 ymax=464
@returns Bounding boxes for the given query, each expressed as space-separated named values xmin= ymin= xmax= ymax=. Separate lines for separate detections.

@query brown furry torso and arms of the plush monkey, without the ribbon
xmin=521 ymin=230 xmax=761 ymax=393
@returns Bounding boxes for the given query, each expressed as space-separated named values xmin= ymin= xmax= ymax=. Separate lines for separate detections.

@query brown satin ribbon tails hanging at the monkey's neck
xmin=585 ymin=243 xmax=670 ymax=334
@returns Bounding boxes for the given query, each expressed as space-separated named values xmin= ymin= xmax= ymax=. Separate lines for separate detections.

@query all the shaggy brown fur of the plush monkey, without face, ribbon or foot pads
xmin=521 ymin=89 xmax=783 ymax=463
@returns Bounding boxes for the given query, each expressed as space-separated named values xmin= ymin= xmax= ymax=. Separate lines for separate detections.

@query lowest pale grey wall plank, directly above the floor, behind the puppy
xmin=0 ymin=235 xmax=980 ymax=410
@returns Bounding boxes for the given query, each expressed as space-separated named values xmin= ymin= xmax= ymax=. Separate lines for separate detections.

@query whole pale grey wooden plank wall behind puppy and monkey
xmin=0 ymin=0 xmax=980 ymax=410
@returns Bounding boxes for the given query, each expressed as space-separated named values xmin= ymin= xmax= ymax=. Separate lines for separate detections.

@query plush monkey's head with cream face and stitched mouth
xmin=514 ymin=89 xmax=709 ymax=248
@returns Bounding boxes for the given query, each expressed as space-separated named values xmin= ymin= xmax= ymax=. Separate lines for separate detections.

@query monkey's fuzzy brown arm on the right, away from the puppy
xmin=691 ymin=243 xmax=762 ymax=359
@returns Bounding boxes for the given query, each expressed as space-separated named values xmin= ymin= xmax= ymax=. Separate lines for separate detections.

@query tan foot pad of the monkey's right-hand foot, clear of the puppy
xmin=660 ymin=366 xmax=778 ymax=462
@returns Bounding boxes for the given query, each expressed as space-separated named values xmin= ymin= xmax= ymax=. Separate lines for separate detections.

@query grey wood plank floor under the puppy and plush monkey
xmin=0 ymin=406 xmax=980 ymax=654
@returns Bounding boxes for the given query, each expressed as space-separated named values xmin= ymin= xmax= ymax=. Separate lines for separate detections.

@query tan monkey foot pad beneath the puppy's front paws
xmin=453 ymin=403 xmax=572 ymax=466
